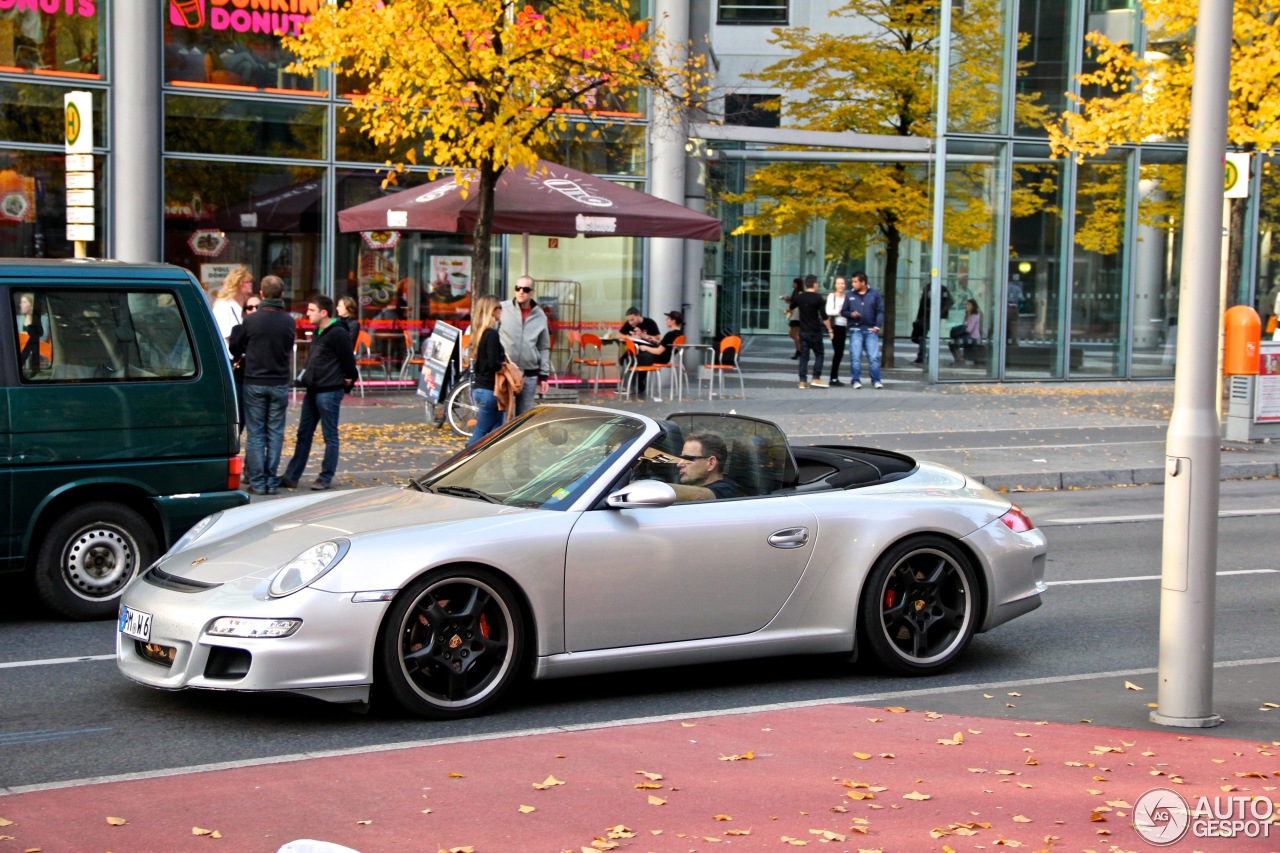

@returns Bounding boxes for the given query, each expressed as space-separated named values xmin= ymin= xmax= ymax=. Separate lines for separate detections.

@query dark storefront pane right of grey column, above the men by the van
xmin=164 ymin=160 xmax=325 ymax=307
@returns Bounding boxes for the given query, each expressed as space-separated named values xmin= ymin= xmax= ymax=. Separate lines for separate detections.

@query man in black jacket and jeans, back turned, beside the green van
xmin=230 ymin=275 xmax=294 ymax=494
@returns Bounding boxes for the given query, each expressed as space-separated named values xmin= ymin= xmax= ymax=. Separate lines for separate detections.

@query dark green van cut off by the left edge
xmin=0 ymin=259 xmax=248 ymax=619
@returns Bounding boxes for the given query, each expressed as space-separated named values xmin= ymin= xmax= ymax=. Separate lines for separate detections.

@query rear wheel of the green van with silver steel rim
xmin=36 ymin=502 xmax=157 ymax=619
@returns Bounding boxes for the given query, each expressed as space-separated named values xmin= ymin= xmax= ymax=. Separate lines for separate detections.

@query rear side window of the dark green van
xmin=13 ymin=288 xmax=196 ymax=384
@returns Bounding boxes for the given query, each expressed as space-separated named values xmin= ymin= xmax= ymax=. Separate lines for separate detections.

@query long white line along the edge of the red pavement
xmin=0 ymin=657 xmax=1280 ymax=797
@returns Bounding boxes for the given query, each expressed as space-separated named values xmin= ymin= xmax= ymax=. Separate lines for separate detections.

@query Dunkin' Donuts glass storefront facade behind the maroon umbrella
xmin=0 ymin=0 xmax=648 ymax=343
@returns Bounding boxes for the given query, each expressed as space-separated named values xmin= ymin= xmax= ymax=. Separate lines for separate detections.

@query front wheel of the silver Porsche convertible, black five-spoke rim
xmin=375 ymin=567 xmax=525 ymax=720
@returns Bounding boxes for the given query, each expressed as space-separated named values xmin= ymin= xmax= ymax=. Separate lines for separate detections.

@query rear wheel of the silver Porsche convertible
xmin=858 ymin=535 xmax=979 ymax=676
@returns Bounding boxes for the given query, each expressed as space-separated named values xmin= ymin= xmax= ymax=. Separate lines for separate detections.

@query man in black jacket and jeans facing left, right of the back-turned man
xmin=280 ymin=296 xmax=358 ymax=492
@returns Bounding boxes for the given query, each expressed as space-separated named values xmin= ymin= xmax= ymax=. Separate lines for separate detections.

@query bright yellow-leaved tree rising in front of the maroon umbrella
xmin=283 ymin=0 xmax=703 ymax=283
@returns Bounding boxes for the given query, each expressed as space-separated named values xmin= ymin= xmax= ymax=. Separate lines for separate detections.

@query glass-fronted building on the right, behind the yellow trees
xmin=707 ymin=0 xmax=1280 ymax=382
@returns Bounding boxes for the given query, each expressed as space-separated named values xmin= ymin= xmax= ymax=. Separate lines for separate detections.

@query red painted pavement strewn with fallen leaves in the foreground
xmin=0 ymin=706 xmax=1280 ymax=853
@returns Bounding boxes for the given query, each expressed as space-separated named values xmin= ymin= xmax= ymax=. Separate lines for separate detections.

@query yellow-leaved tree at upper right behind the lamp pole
xmin=1046 ymin=0 xmax=1280 ymax=293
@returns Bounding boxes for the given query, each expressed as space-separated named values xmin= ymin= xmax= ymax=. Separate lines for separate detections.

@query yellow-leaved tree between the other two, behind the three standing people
xmin=727 ymin=0 xmax=1043 ymax=358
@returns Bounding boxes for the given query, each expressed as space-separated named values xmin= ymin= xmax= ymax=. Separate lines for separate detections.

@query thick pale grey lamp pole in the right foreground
xmin=1151 ymin=0 xmax=1233 ymax=729
